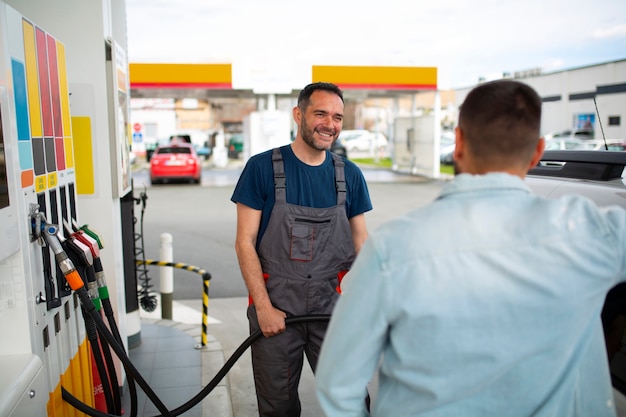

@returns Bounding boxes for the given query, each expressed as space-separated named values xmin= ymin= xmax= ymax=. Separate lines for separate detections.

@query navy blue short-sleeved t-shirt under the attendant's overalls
xmin=231 ymin=145 xmax=372 ymax=248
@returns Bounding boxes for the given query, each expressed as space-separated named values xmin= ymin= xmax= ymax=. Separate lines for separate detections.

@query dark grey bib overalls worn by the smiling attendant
xmin=248 ymin=149 xmax=355 ymax=417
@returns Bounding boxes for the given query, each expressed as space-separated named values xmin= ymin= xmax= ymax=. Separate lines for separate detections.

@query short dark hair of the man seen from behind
xmin=459 ymin=80 xmax=541 ymax=162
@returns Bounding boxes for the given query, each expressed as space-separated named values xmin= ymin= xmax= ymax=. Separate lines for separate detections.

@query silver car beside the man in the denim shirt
xmin=526 ymin=150 xmax=626 ymax=416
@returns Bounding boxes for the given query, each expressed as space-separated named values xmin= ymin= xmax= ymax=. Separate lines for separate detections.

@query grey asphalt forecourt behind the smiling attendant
xmin=133 ymin=153 xmax=444 ymax=300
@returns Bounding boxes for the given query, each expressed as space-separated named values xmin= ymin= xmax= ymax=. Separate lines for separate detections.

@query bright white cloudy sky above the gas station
xmin=126 ymin=0 xmax=626 ymax=89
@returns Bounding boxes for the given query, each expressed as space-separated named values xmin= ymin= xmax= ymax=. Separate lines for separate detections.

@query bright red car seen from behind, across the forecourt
xmin=150 ymin=143 xmax=202 ymax=184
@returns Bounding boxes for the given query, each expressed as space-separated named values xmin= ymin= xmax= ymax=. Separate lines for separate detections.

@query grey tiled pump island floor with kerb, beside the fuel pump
xmin=122 ymin=296 xmax=234 ymax=417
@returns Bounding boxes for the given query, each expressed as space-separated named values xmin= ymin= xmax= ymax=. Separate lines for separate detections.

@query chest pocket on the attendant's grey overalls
xmin=290 ymin=218 xmax=332 ymax=261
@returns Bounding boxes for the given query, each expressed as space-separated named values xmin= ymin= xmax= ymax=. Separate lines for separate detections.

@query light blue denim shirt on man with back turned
xmin=316 ymin=173 xmax=626 ymax=417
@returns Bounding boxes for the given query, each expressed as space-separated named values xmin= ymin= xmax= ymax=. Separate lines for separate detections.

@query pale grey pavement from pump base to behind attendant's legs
xmin=125 ymin=297 xmax=322 ymax=417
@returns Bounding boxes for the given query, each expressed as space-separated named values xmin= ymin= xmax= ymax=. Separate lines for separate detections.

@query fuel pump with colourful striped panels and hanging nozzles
xmin=0 ymin=0 xmax=130 ymax=417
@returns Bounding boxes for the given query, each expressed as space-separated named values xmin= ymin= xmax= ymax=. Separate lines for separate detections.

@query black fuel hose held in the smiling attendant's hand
xmin=61 ymin=314 xmax=330 ymax=417
